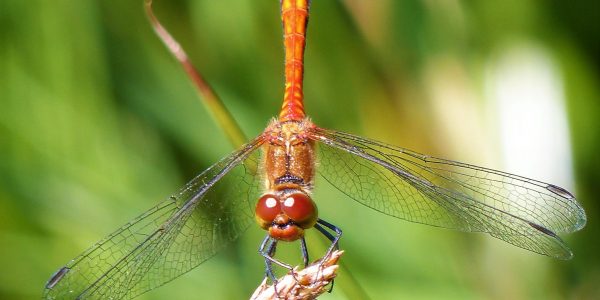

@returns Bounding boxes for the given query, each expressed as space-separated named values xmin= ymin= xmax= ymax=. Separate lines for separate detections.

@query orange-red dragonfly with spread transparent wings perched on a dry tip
xmin=44 ymin=0 xmax=586 ymax=299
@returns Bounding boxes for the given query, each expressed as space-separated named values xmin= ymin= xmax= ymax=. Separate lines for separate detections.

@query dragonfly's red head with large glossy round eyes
xmin=255 ymin=191 xmax=317 ymax=241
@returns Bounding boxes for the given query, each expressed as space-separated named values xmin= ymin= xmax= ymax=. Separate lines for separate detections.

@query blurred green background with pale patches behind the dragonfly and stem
xmin=0 ymin=0 xmax=600 ymax=299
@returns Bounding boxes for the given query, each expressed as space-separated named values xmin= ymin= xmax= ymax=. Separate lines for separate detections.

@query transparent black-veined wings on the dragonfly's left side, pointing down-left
xmin=44 ymin=138 xmax=262 ymax=299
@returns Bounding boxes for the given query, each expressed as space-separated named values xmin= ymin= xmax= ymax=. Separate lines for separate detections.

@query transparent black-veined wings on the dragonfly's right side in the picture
xmin=311 ymin=128 xmax=586 ymax=259
